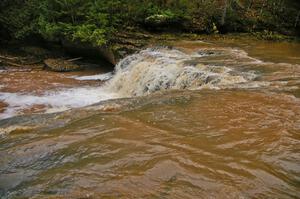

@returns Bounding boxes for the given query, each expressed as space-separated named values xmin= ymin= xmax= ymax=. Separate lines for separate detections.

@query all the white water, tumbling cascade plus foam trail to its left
xmin=0 ymin=48 xmax=257 ymax=119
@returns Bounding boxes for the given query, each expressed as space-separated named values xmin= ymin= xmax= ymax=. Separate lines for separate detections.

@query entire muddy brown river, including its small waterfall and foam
xmin=0 ymin=40 xmax=300 ymax=198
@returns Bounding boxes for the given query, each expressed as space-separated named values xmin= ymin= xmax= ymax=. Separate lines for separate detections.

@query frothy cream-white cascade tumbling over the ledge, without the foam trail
xmin=105 ymin=48 xmax=256 ymax=97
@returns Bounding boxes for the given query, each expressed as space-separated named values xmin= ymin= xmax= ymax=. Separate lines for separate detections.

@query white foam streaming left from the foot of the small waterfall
xmin=0 ymin=87 xmax=119 ymax=119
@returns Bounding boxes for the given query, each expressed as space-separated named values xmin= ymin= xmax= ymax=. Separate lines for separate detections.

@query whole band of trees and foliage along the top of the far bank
xmin=0 ymin=0 xmax=300 ymax=45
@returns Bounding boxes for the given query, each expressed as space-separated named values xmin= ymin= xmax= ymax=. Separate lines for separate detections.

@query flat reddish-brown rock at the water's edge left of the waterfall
xmin=44 ymin=59 xmax=82 ymax=72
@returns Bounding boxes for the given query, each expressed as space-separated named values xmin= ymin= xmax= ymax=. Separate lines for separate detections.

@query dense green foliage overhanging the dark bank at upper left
xmin=0 ymin=0 xmax=116 ymax=45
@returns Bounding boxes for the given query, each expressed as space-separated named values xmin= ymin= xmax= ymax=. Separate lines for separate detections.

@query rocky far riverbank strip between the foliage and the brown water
xmin=0 ymin=31 xmax=300 ymax=71
